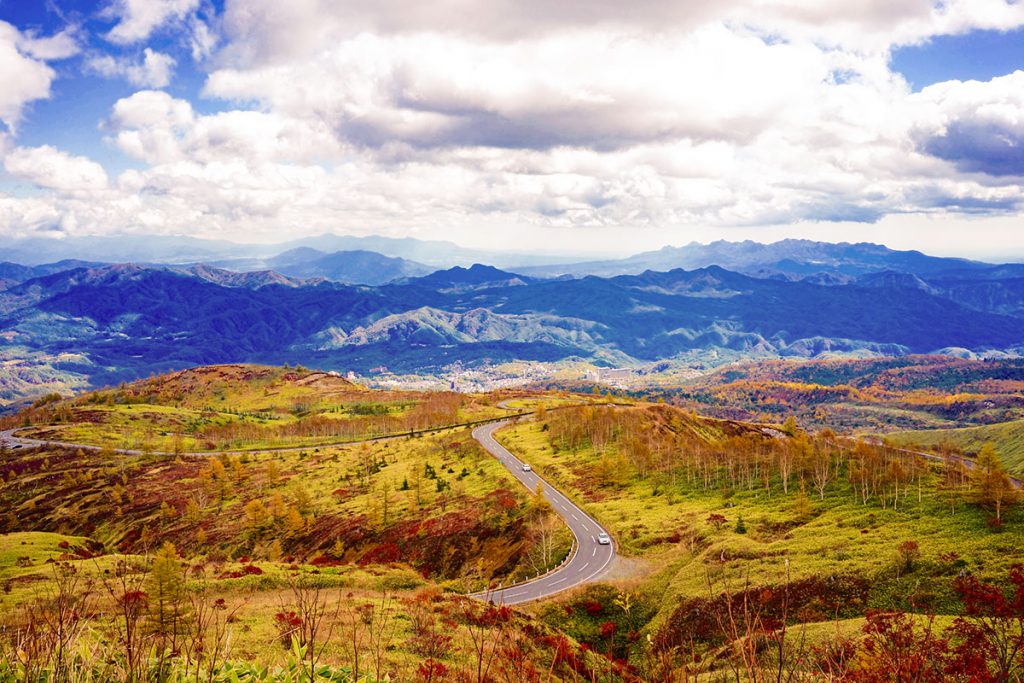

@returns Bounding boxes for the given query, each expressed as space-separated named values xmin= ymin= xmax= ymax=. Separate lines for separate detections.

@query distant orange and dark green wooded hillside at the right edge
xmin=655 ymin=355 xmax=1024 ymax=433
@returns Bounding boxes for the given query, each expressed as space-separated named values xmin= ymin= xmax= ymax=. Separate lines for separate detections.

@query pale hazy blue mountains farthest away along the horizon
xmin=6 ymin=234 xmax=1024 ymax=285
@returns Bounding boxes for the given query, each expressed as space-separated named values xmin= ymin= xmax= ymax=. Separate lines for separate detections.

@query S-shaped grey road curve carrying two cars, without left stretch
xmin=473 ymin=420 xmax=615 ymax=605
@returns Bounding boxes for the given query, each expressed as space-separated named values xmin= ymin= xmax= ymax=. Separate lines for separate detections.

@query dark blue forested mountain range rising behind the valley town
xmin=0 ymin=243 xmax=1024 ymax=395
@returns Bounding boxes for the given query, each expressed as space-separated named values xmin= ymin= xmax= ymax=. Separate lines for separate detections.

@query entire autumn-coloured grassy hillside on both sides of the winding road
xmin=0 ymin=376 xmax=1024 ymax=683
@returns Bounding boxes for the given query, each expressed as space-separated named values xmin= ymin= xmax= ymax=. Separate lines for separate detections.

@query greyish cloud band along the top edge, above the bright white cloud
xmin=224 ymin=0 xmax=1024 ymax=62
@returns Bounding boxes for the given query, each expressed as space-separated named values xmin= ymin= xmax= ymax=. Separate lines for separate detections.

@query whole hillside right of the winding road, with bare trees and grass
xmin=493 ymin=405 xmax=1022 ymax=680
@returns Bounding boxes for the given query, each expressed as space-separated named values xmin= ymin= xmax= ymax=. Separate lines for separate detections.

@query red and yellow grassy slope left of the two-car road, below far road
xmin=0 ymin=423 xmax=565 ymax=579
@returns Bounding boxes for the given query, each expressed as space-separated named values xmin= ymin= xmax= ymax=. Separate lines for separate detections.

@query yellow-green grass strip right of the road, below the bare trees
xmin=500 ymin=411 xmax=1024 ymax=626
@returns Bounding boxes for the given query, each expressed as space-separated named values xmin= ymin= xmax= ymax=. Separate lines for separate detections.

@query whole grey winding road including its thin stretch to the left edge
xmin=0 ymin=405 xmax=615 ymax=605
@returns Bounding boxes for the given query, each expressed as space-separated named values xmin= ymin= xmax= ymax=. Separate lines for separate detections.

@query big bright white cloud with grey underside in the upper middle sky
xmin=207 ymin=26 xmax=833 ymax=148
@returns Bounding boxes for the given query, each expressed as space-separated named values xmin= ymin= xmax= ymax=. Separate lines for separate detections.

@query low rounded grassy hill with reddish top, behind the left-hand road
xmin=12 ymin=365 xmax=516 ymax=452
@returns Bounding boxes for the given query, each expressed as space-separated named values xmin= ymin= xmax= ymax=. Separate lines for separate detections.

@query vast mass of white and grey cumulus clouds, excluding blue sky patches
xmin=0 ymin=0 xmax=1024 ymax=253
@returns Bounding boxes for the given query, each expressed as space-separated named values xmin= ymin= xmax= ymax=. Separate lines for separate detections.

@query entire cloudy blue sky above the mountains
xmin=0 ymin=0 xmax=1024 ymax=260
